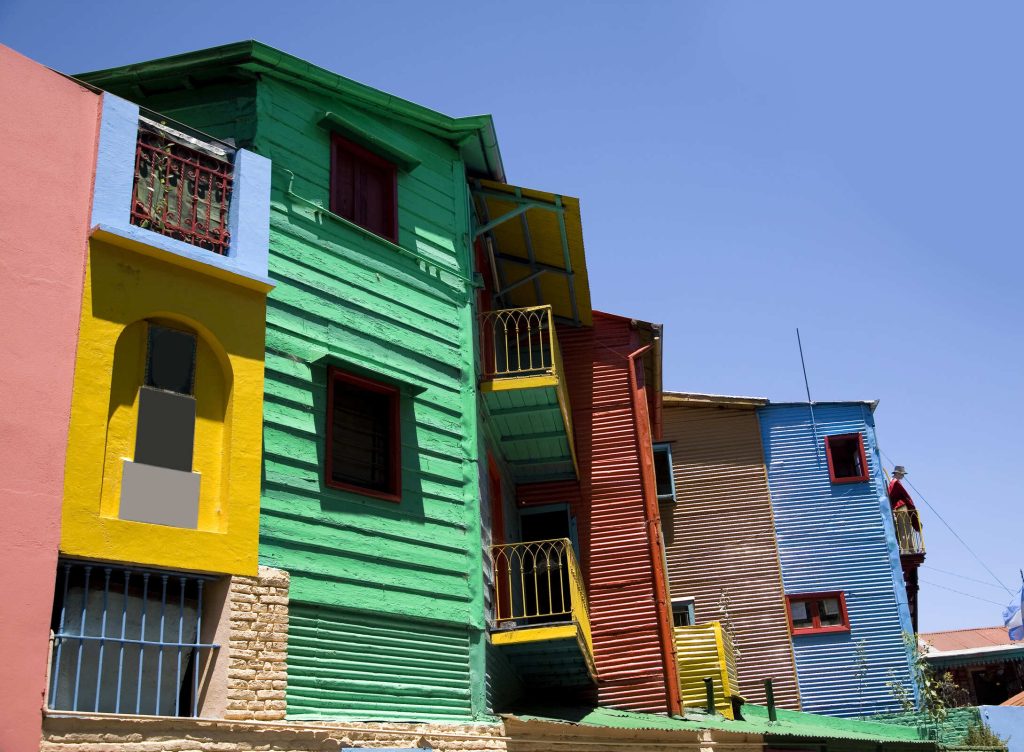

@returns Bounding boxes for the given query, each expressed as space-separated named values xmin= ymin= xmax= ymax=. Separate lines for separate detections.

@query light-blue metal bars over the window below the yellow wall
xmin=48 ymin=560 xmax=219 ymax=717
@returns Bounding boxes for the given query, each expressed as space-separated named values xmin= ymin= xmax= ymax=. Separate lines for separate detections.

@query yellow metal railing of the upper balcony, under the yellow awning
xmin=480 ymin=305 xmax=561 ymax=378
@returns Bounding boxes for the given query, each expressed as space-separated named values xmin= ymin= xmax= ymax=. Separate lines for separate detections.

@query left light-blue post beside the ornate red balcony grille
xmin=91 ymin=93 xmax=138 ymax=226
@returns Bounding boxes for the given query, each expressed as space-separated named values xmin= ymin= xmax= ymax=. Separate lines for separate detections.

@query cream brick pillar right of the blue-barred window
xmin=223 ymin=567 xmax=289 ymax=720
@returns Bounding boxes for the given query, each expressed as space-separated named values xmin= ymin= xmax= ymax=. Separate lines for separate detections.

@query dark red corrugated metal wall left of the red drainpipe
xmin=517 ymin=311 xmax=676 ymax=713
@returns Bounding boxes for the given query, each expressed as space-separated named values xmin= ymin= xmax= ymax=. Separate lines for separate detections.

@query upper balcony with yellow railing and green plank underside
xmin=480 ymin=305 xmax=577 ymax=483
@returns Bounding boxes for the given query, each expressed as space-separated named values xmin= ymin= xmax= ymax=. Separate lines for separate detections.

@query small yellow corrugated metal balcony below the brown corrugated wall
xmin=675 ymin=622 xmax=739 ymax=718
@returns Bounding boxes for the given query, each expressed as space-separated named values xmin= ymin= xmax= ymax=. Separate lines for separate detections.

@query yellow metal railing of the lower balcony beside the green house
xmin=490 ymin=538 xmax=593 ymax=651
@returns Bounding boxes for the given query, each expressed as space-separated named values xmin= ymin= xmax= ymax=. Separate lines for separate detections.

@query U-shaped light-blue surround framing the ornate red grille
xmin=92 ymin=93 xmax=274 ymax=287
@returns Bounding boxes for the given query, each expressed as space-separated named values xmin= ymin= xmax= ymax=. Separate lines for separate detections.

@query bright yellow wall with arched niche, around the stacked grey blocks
xmin=60 ymin=238 xmax=266 ymax=575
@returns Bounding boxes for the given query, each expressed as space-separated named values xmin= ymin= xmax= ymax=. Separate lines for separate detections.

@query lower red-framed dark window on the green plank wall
xmin=325 ymin=368 xmax=401 ymax=501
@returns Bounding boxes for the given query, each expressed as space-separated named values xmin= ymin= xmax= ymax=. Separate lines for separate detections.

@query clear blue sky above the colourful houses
xmin=0 ymin=0 xmax=1024 ymax=630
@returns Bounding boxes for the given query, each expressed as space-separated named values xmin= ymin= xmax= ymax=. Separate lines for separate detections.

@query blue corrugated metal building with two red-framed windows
xmin=758 ymin=402 xmax=916 ymax=717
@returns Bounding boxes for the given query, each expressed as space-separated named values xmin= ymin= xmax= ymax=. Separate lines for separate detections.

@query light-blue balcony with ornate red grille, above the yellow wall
xmin=90 ymin=93 xmax=273 ymax=293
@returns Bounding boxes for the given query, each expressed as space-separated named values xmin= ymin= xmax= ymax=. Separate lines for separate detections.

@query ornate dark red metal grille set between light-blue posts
xmin=131 ymin=118 xmax=234 ymax=255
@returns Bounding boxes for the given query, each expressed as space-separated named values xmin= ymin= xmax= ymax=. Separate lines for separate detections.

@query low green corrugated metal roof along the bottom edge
xmin=507 ymin=705 xmax=935 ymax=747
